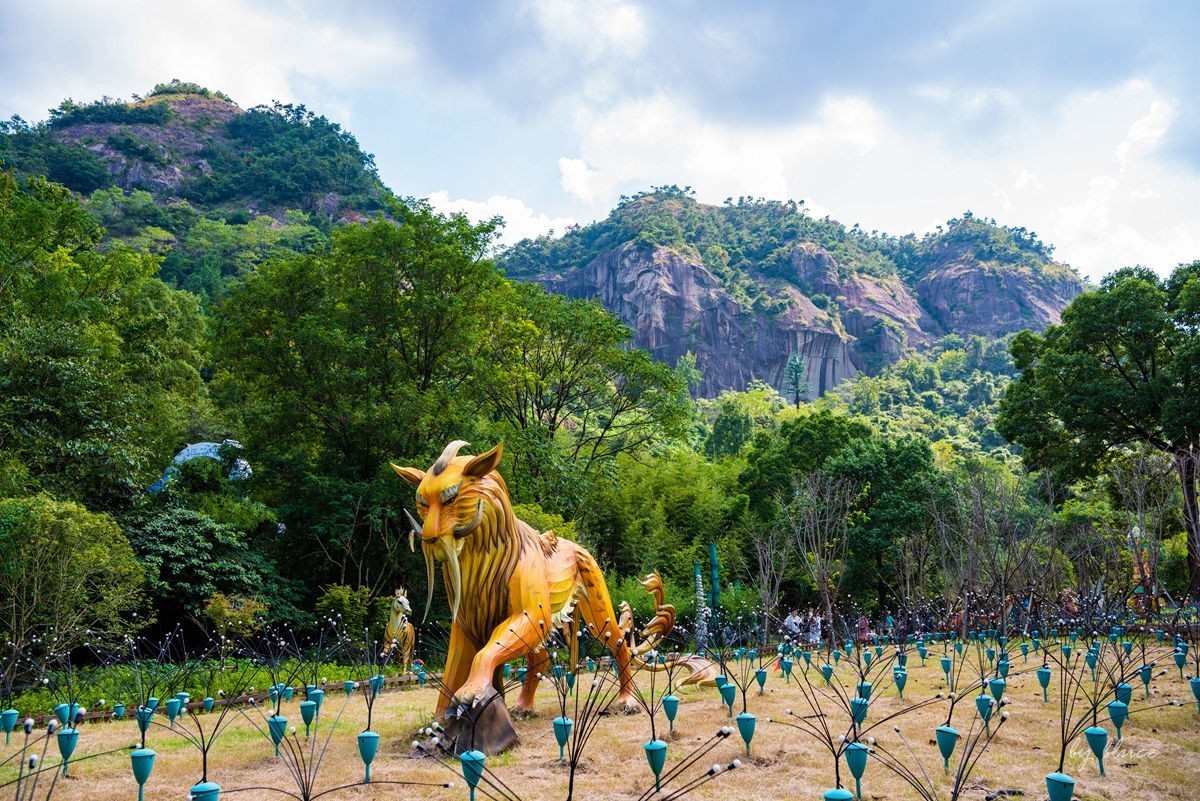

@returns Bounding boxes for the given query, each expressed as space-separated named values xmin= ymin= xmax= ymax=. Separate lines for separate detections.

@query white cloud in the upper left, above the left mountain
xmin=0 ymin=0 xmax=412 ymax=122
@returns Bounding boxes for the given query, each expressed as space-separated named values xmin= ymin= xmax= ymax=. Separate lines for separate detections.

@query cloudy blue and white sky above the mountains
xmin=0 ymin=0 xmax=1200 ymax=281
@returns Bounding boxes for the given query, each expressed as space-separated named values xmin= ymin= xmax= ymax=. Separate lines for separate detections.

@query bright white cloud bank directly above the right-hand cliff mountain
xmin=559 ymin=82 xmax=1200 ymax=278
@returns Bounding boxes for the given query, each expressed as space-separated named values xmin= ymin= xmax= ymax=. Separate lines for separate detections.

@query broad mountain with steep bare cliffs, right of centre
xmin=500 ymin=186 xmax=1082 ymax=397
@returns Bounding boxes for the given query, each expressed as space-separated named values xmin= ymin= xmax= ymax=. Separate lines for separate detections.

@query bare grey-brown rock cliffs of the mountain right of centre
xmin=538 ymin=242 xmax=1079 ymax=397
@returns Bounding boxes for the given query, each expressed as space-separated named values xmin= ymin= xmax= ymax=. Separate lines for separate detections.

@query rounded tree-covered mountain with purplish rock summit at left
xmin=0 ymin=80 xmax=390 ymax=299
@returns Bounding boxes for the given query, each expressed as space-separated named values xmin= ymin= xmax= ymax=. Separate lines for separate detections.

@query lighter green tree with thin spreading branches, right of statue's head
xmin=475 ymin=284 xmax=691 ymax=514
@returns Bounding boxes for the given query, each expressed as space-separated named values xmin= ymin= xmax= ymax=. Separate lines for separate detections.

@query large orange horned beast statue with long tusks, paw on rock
xmin=391 ymin=440 xmax=674 ymax=753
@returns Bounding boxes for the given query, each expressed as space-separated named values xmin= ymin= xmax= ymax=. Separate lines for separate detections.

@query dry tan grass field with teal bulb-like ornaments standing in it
xmin=7 ymin=654 xmax=1200 ymax=801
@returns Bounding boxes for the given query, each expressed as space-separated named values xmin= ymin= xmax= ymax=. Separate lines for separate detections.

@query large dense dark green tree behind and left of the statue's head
xmin=214 ymin=201 xmax=502 ymax=595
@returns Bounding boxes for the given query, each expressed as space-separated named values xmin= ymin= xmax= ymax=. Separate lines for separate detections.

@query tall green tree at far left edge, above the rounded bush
xmin=0 ymin=174 xmax=204 ymax=510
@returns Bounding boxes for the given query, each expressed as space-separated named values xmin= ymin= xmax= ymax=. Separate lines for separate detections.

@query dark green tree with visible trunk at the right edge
xmin=996 ymin=267 xmax=1200 ymax=591
